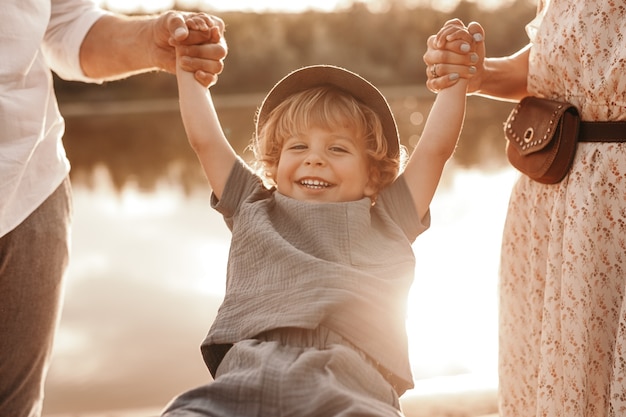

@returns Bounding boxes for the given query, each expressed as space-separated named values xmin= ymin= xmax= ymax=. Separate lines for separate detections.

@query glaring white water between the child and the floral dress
xmin=407 ymin=166 xmax=517 ymax=386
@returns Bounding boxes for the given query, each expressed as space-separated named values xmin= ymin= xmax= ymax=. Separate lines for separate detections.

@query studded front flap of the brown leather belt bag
xmin=504 ymin=96 xmax=578 ymax=155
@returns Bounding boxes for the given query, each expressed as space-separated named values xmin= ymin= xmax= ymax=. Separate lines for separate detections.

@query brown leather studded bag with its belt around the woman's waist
xmin=504 ymin=96 xmax=626 ymax=184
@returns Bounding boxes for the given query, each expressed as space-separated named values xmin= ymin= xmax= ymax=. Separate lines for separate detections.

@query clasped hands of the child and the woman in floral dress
xmin=424 ymin=19 xmax=485 ymax=92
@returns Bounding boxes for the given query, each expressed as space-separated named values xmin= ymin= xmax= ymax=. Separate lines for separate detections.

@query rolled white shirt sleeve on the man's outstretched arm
xmin=42 ymin=0 xmax=113 ymax=83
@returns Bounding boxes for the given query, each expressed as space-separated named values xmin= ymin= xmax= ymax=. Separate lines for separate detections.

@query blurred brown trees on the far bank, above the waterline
xmin=56 ymin=0 xmax=535 ymax=100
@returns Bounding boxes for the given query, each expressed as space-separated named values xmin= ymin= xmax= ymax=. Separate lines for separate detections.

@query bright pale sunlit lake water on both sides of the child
xmin=45 ymin=165 xmax=517 ymax=415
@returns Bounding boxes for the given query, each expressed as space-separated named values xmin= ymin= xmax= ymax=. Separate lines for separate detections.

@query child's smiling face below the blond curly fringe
xmin=271 ymin=127 xmax=375 ymax=203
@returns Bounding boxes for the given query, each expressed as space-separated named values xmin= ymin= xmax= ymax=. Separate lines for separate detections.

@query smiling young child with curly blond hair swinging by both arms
xmin=164 ymin=17 xmax=466 ymax=417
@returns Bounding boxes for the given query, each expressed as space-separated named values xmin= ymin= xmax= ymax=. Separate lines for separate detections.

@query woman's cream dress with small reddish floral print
xmin=499 ymin=0 xmax=626 ymax=417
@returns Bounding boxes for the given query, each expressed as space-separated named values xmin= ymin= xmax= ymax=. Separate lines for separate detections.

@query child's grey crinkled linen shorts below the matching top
xmin=163 ymin=328 xmax=402 ymax=417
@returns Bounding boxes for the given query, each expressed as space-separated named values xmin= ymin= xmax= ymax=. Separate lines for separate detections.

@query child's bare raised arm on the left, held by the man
xmin=176 ymin=20 xmax=237 ymax=198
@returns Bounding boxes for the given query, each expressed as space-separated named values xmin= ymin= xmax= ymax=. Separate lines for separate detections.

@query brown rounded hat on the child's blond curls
xmin=256 ymin=65 xmax=400 ymax=157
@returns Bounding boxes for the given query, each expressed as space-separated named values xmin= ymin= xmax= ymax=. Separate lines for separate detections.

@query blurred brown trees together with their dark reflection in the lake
xmin=55 ymin=0 xmax=535 ymax=190
